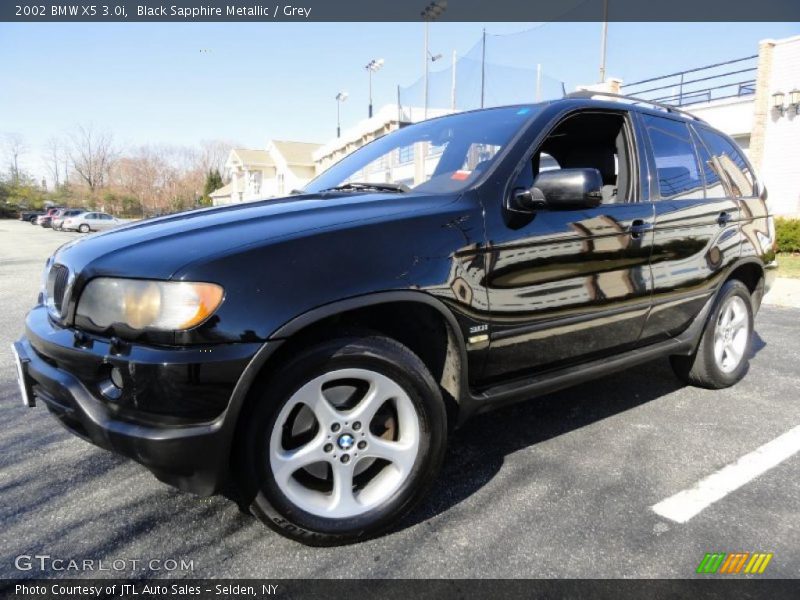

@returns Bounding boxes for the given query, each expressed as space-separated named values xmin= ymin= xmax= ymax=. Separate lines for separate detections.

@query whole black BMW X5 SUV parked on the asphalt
xmin=14 ymin=92 xmax=775 ymax=544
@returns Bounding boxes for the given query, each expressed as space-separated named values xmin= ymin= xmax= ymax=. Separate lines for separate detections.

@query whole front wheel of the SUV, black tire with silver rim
xmin=237 ymin=334 xmax=447 ymax=546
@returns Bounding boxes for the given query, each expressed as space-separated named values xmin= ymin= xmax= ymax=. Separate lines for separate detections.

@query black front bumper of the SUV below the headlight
xmin=14 ymin=307 xmax=263 ymax=495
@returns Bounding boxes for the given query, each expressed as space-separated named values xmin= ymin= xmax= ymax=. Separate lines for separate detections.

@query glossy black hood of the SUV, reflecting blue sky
xmin=54 ymin=193 xmax=454 ymax=279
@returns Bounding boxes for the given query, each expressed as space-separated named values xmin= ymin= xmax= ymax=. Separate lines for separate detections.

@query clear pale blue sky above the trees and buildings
xmin=0 ymin=23 xmax=800 ymax=177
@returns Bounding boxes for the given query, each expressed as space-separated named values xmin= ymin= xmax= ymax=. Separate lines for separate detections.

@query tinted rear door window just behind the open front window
xmin=643 ymin=115 xmax=704 ymax=200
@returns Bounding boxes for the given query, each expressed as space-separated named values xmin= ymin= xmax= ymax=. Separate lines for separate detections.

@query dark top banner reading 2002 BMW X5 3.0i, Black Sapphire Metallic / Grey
xmin=0 ymin=0 xmax=800 ymax=22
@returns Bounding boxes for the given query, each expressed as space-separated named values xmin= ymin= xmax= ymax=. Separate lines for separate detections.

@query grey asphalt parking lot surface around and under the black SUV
xmin=0 ymin=221 xmax=800 ymax=578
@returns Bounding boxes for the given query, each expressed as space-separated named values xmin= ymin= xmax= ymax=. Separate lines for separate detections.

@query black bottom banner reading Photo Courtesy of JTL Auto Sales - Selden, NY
xmin=0 ymin=579 xmax=797 ymax=600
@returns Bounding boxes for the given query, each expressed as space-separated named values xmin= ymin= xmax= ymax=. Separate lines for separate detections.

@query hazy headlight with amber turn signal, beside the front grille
xmin=77 ymin=277 xmax=223 ymax=331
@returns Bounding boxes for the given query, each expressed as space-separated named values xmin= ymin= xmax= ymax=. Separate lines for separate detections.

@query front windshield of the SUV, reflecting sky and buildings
xmin=304 ymin=106 xmax=540 ymax=193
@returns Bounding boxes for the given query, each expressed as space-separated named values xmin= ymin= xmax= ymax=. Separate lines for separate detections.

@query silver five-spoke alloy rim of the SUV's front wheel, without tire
xmin=269 ymin=368 xmax=420 ymax=519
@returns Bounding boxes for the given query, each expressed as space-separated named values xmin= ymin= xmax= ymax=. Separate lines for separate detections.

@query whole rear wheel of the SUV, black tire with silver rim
xmin=670 ymin=279 xmax=753 ymax=389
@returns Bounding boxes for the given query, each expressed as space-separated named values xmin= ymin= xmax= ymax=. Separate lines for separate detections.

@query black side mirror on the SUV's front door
xmin=512 ymin=169 xmax=603 ymax=212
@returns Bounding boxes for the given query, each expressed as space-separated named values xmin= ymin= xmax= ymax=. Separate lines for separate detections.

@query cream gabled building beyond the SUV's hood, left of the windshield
xmin=216 ymin=140 xmax=319 ymax=206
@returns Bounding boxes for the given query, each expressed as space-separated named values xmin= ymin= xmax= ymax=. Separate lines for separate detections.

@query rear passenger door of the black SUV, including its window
xmin=640 ymin=113 xmax=739 ymax=341
